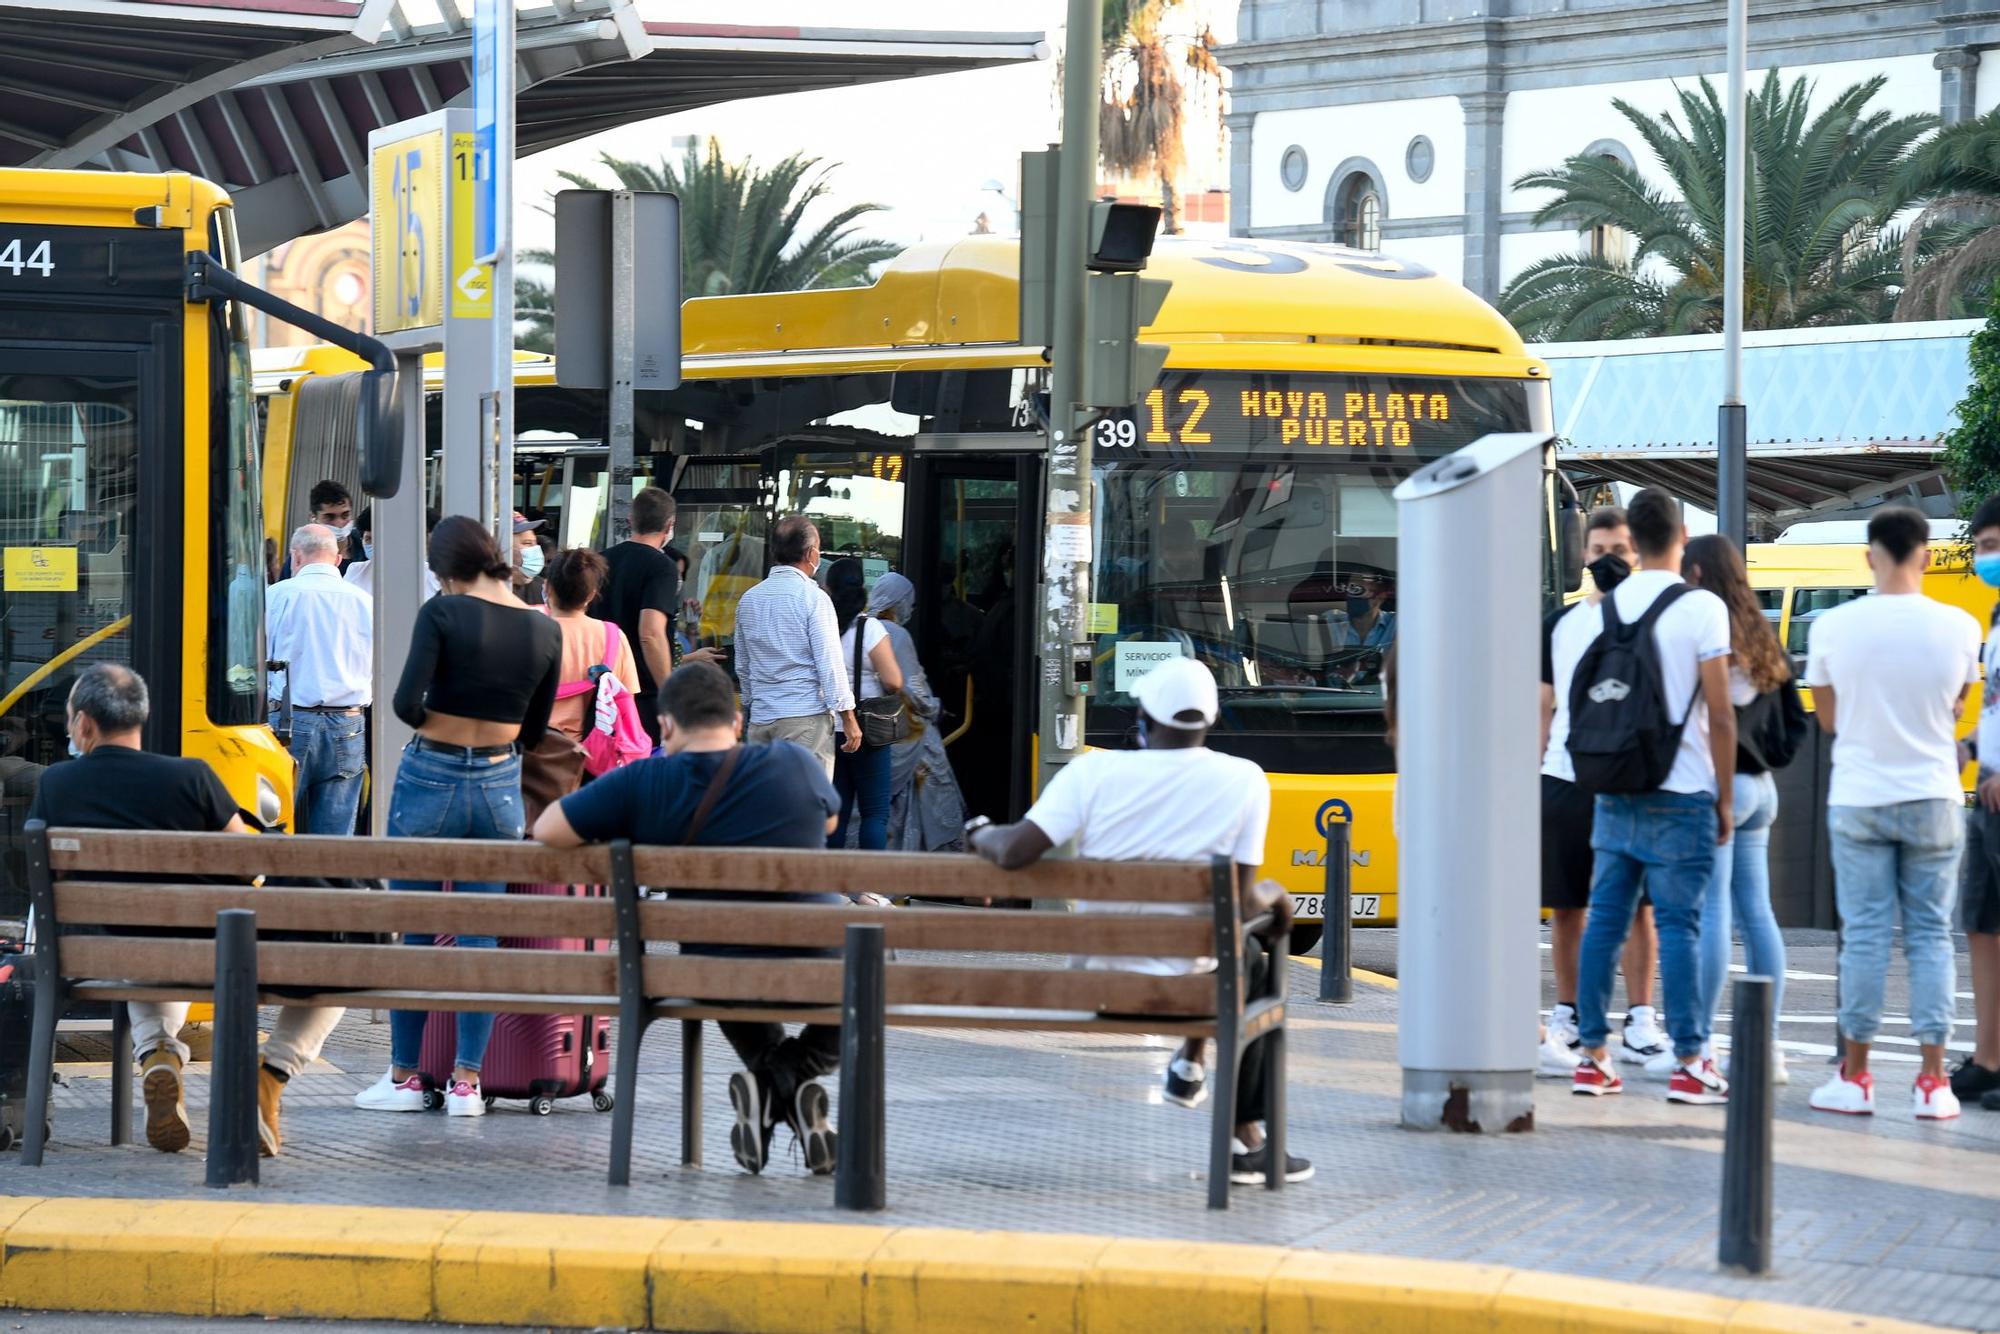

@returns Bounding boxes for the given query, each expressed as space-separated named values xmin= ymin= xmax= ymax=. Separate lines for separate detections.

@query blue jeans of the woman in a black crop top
xmin=388 ymin=742 xmax=522 ymax=1070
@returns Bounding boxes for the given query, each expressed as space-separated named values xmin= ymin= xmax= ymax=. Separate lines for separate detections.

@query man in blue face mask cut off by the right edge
xmin=1952 ymin=496 xmax=2000 ymax=1112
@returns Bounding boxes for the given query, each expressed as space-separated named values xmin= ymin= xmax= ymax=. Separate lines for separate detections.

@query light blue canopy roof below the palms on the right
xmin=1532 ymin=320 xmax=1980 ymax=530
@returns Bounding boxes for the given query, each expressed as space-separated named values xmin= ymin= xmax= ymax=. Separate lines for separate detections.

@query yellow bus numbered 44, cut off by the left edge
xmin=0 ymin=170 xmax=388 ymax=916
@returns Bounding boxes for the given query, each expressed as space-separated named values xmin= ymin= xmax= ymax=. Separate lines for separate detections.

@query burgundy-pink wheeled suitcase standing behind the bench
xmin=418 ymin=884 xmax=612 ymax=1116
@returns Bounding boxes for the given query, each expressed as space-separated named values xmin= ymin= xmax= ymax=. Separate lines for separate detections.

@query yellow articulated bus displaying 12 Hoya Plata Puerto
xmin=264 ymin=236 xmax=1568 ymax=944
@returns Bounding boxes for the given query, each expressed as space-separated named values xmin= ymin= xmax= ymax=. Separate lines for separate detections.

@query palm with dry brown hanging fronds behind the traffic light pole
xmin=1098 ymin=0 xmax=1222 ymax=236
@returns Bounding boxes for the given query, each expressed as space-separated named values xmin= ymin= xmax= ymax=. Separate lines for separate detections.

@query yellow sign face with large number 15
xmin=368 ymin=128 xmax=446 ymax=334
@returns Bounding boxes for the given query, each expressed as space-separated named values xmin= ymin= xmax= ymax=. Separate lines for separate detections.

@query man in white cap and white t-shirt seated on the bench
xmin=972 ymin=658 xmax=1312 ymax=1186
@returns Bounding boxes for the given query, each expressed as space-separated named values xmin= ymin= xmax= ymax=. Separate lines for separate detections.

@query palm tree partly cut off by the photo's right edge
xmin=1882 ymin=108 xmax=2000 ymax=320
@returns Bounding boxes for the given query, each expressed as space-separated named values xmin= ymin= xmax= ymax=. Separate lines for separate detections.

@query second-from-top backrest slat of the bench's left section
xmin=56 ymin=880 xmax=616 ymax=940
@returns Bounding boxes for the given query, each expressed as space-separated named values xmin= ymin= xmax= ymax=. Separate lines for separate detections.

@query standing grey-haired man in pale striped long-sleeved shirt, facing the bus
xmin=736 ymin=514 xmax=862 ymax=778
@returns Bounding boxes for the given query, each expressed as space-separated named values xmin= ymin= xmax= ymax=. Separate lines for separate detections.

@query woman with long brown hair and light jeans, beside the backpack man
xmin=1680 ymin=534 xmax=1796 ymax=1084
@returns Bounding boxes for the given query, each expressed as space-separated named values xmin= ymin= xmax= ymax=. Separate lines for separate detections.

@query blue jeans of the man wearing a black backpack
xmin=1576 ymin=792 xmax=1716 ymax=1060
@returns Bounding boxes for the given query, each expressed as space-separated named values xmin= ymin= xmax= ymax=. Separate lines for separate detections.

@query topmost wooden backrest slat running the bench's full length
xmin=39 ymin=828 xmax=1210 ymax=904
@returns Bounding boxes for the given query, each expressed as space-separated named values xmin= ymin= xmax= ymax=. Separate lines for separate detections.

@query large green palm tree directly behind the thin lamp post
xmin=1500 ymin=70 xmax=1936 ymax=340
